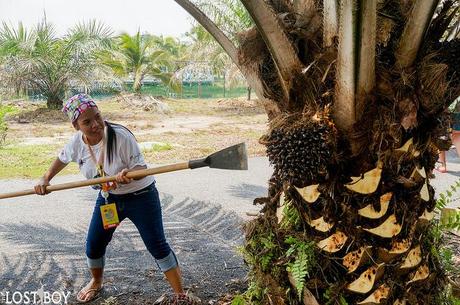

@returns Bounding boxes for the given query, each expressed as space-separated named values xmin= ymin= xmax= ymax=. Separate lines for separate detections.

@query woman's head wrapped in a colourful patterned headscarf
xmin=62 ymin=93 xmax=104 ymax=137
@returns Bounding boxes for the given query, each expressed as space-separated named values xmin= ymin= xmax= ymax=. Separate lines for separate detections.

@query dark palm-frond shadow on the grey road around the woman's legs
xmin=0 ymin=194 xmax=247 ymax=304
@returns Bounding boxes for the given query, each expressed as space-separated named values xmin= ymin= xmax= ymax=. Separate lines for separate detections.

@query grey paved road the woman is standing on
xmin=0 ymin=151 xmax=460 ymax=304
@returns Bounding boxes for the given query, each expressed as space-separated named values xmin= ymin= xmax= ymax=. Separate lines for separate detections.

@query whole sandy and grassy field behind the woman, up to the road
xmin=0 ymin=97 xmax=267 ymax=178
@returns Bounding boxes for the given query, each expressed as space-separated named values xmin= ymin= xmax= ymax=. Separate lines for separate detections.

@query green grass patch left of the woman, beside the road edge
xmin=0 ymin=145 xmax=78 ymax=179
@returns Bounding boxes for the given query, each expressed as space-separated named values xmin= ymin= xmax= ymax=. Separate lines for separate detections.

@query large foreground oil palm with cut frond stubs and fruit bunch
xmin=175 ymin=0 xmax=460 ymax=304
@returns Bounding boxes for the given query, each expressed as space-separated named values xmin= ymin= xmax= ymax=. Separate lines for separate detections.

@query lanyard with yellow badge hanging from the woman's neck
xmin=85 ymin=128 xmax=120 ymax=230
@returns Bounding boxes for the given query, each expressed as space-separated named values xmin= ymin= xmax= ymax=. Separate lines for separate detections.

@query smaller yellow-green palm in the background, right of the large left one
xmin=99 ymin=31 xmax=174 ymax=93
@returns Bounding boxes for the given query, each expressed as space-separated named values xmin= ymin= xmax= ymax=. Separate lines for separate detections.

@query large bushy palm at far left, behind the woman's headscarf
xmin=0 ymin=20 xmax=111 ymax=108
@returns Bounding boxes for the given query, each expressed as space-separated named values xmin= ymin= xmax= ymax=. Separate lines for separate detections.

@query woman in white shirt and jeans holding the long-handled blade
xmin=35 ymin=94 xmax=195 ymax=303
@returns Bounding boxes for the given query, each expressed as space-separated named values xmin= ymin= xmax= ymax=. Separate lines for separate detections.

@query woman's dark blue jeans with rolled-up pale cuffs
xmin=86 ymin=183 xmax=178 ymax=272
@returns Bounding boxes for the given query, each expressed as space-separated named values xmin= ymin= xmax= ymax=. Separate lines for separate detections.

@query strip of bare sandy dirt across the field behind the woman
xmin=3 ymin=98 xmax=266 ymax=145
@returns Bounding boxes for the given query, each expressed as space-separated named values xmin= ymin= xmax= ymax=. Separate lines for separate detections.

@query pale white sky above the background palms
xmin=0 ymin=0 xmax=192 ymax=37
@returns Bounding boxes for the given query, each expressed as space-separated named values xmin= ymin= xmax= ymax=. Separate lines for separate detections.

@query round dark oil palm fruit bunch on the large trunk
xmin=260 ymin=113 xmax=337 ymax=187
